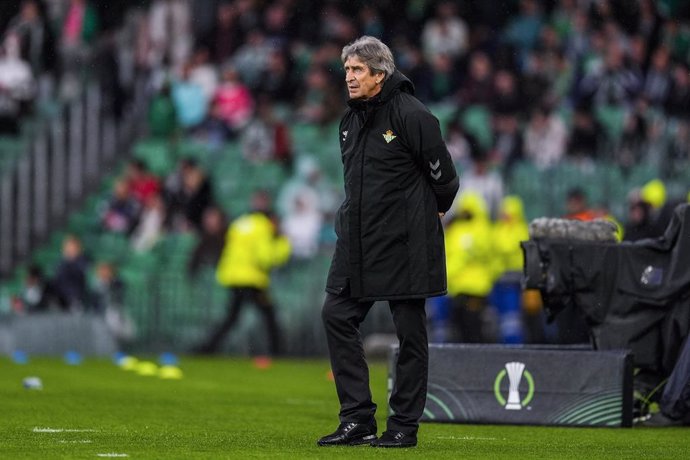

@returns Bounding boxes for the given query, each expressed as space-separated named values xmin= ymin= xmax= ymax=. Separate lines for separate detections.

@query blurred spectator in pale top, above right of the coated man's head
xmin=421 ymin=1 xmax=469 ymax=62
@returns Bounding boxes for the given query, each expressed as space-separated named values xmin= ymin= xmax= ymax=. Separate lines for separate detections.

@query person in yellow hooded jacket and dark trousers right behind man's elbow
xmin=446 ymin=191 xmax=497 ymax=343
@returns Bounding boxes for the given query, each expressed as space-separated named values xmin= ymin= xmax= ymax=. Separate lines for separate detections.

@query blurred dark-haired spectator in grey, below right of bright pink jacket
xmin=241 ymin=97 xmax=292 ymax=166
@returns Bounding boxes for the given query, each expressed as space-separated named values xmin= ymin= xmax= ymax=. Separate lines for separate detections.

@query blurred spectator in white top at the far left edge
xmin=0 ymin=35 xmax=35 ymax=135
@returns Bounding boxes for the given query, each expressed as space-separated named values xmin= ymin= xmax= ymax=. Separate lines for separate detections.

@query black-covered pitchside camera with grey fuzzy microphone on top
xmin=522 ymin=204 xmax=690 ymax=378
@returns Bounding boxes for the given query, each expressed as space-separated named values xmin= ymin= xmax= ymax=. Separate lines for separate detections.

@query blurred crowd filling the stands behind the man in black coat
xmin=0 ymin=0 xmax=690 ymax=353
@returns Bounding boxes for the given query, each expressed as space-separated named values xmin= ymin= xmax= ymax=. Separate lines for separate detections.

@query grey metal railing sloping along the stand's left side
xmin=0 ymin=16 xmax=148 ymax=280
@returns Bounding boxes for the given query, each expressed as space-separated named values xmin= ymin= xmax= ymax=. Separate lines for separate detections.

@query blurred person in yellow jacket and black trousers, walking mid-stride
xmin=198 ymin=197 xmax=290 ymax=356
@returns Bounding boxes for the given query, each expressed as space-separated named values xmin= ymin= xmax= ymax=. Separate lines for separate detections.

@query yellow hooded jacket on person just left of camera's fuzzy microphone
xmin=493 ymin=195 xmax=529 ymax=274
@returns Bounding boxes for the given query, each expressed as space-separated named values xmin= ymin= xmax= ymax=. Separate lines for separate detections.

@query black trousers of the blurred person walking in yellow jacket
xmin=200 ymin=287 xmax=281 ymax=356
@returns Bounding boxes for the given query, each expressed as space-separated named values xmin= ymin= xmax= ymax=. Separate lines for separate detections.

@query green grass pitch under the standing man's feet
xmin=0 ymin=357 xmax=690 ymax=459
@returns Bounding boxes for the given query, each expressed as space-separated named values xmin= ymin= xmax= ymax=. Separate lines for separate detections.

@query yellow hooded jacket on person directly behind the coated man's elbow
xmin=446 ymin=192 xmax=497 ymax=297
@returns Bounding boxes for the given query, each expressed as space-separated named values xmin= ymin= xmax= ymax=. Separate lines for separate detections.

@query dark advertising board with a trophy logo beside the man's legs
xmin=389 ymin=344 xmax=633 ymax=427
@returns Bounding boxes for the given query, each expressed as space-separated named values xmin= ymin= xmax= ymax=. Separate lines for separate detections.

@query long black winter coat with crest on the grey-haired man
xmin=326 ymin=71 xmax=458 ymax=301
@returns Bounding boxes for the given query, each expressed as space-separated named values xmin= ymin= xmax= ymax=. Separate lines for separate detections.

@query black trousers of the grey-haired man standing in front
xmin=322 ymin=294 xmax=429 ymax=434
